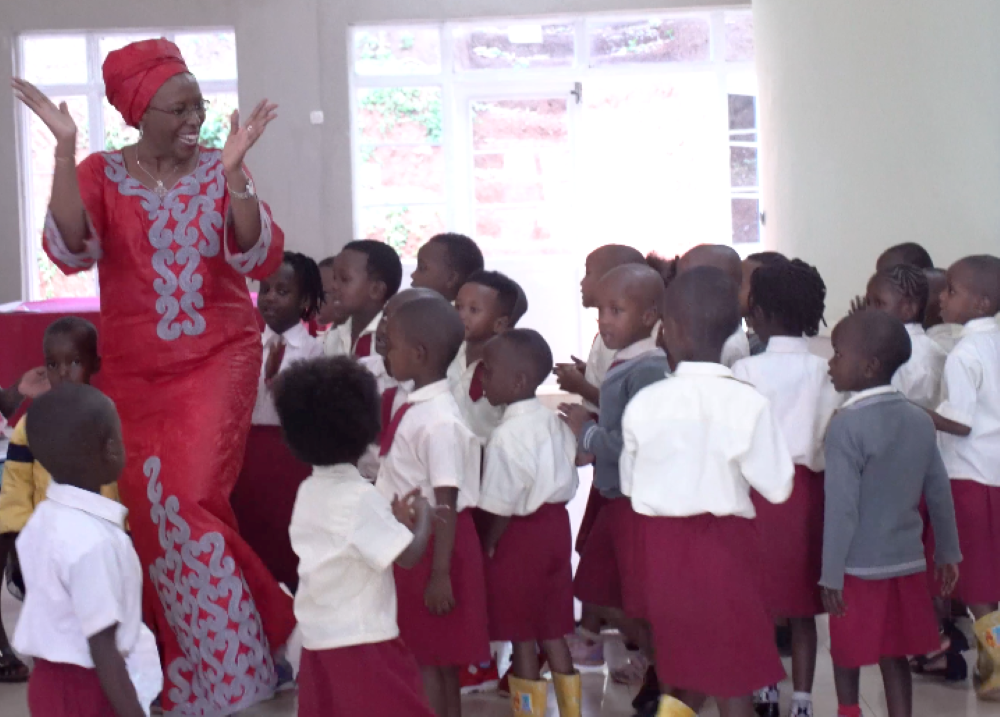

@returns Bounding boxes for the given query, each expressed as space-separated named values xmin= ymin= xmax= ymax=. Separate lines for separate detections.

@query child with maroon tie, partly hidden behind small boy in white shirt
xmin=448 ymin=271 xmax=527 ymax=445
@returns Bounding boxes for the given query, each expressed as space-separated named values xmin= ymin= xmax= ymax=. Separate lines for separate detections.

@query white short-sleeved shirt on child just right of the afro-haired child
xmin=375 ymin=380 xmax=482 ymax=511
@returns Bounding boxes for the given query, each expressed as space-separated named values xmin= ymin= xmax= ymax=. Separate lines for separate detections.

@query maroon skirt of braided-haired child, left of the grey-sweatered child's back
xmin=751 ymin=466 xmax=825 ymax=617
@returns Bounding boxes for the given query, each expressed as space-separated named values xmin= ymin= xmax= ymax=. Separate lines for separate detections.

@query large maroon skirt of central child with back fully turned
xmin=635 ymin=515 xmax=785 ymax=698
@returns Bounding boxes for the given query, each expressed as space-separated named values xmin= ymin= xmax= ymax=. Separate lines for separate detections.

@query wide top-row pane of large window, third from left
xmin=589 ymin=16 xmax=711 ymax=66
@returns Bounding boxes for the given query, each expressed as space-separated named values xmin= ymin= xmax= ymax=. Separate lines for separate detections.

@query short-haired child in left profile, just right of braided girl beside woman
xmin=323 ymin=239 xmax=403 ymax=358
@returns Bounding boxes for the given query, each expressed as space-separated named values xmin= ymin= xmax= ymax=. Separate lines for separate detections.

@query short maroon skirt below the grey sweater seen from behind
xmin=830 ymin=573 xmax=941 ymax=668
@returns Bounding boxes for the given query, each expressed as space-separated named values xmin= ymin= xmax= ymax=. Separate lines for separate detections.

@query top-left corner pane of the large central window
xmin=354 ymin=27 xmax=441 ymax=75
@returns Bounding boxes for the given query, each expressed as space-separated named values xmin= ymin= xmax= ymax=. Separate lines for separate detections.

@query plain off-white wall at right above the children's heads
xmin=754 ymin=0 xmax=1000 ymax=318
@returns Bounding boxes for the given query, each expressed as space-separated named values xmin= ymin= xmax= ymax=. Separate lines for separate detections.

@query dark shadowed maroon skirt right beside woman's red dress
xmin=229 ymin=426 xmax=312 ymax=592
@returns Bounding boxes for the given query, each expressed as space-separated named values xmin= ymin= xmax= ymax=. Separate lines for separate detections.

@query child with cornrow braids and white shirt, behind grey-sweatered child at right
xmin=865 ymin=264 xmax=948 ymax=410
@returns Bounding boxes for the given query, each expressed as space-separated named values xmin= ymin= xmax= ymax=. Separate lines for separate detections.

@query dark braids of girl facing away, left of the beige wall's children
xmin=750 ymin=259 xmax=826 ymax=336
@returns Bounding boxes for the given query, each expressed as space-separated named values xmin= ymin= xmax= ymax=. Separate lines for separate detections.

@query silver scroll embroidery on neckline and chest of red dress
xmin=104 ymin=150 xmax=226 ymax=341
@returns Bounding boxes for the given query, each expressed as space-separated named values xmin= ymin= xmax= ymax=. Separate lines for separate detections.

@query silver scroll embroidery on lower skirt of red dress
xmin=142 ymin=456 xmax=277 ymax=717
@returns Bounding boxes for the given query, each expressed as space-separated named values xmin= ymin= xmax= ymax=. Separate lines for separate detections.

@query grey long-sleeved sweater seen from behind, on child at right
xmin=820 ymin=392 xmax=962 ymax=590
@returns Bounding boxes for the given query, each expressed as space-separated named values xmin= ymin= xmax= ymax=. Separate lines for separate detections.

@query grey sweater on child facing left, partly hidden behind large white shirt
xmin=580 ymin=349 xmax=670 ymax=498
